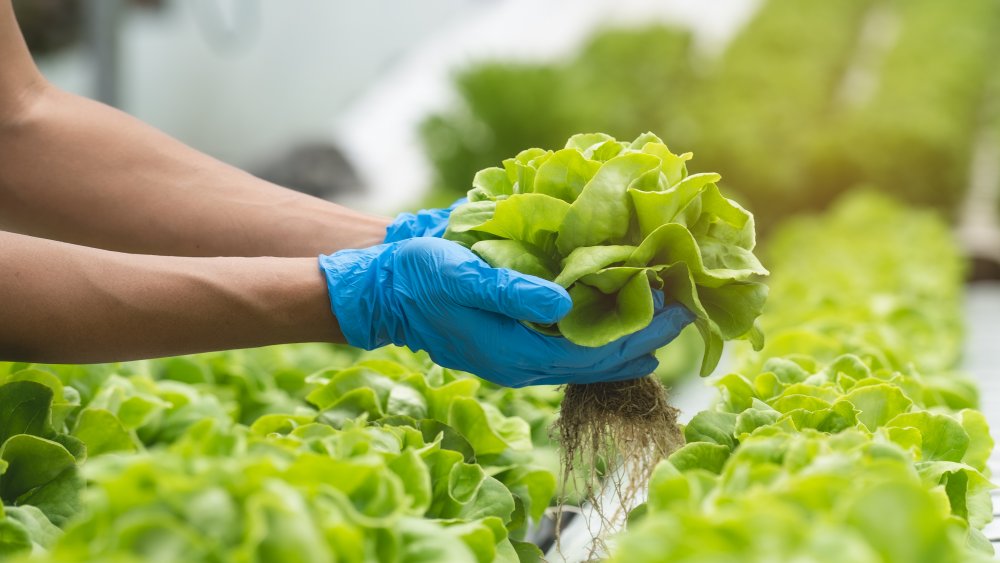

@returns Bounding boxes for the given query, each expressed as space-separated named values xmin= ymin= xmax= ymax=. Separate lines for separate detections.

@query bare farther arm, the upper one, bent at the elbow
xmin=0 ymin=0 xmax=389 ymax=256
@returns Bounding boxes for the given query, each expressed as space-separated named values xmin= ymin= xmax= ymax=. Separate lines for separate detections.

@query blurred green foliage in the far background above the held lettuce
xmin=422 ymin=0 xmax=1000 ymax=229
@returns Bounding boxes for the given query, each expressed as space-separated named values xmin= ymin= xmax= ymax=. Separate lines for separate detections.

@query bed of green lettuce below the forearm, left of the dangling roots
xmin=0 ymin=346 xmax=556 ymax=561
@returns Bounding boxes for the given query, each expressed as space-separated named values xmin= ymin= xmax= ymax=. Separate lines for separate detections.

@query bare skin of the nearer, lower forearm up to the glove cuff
xmin=0 ymin=232 xmax=342 ymax=363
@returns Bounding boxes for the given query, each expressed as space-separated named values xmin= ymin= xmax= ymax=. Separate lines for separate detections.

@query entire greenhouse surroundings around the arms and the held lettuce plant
xmin=0 ymin=0 xmax=1000 ymax=563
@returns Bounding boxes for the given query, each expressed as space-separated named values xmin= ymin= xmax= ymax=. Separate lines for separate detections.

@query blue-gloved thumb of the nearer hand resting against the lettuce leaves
xmin=442 ymin=256 xmax=573 ymax=324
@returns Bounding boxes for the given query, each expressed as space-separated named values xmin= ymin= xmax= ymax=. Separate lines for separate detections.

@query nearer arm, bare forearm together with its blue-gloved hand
xmin=0 ymin=232 xmax=691 ymax=387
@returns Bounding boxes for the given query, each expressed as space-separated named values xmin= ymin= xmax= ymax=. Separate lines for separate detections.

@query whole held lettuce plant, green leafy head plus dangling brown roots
xmin=444 ymin=133 xmax=768 ymax=552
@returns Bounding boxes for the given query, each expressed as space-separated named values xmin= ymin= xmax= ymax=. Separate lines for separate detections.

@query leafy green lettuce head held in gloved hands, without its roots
xmin=445 ymin=133 xmax=768 ymax=375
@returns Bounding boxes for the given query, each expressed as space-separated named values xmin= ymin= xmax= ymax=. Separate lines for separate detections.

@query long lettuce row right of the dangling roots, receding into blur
xmin=614 ymin=195 xmax=994 ymax=562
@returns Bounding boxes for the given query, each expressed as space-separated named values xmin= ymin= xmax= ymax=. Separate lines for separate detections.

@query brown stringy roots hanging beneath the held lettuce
xmin=553 ymin=376 xmax=684 ymax=545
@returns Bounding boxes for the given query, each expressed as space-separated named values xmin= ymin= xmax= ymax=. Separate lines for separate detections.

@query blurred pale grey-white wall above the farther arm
xmin=40 ymin=0 xmax=490 ymax=165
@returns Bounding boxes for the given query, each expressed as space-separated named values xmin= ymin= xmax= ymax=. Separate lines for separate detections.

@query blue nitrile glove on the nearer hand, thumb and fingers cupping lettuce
xmin=319 ymin=237 xmax=693 ymax=387
